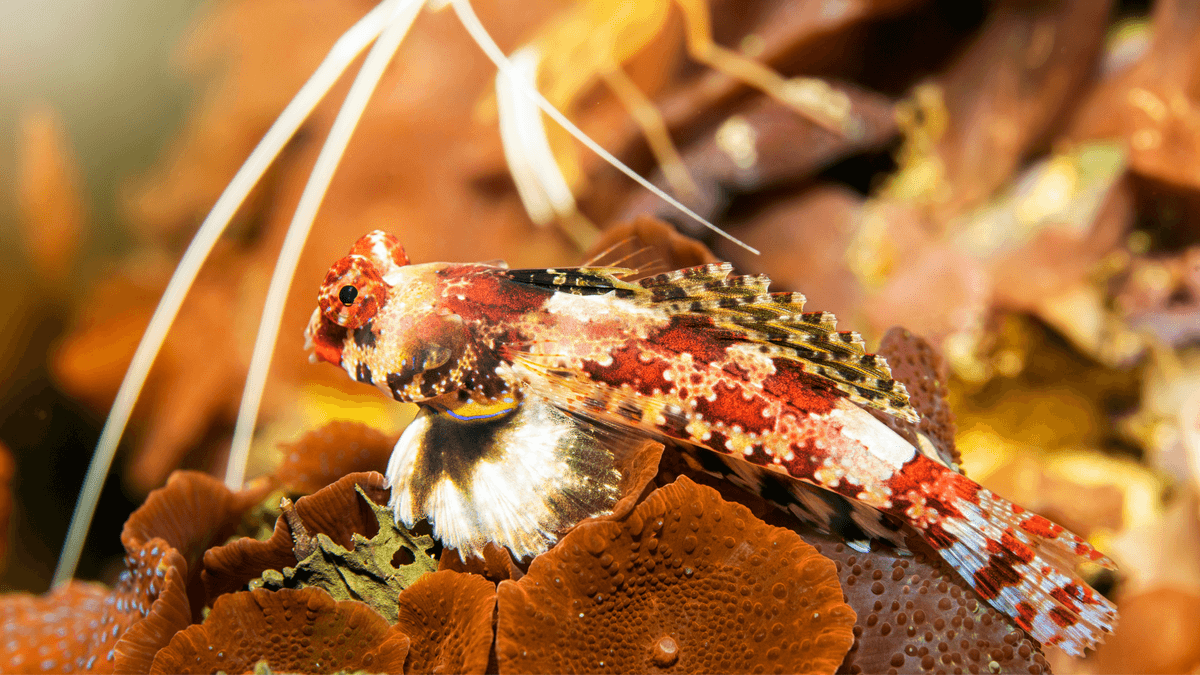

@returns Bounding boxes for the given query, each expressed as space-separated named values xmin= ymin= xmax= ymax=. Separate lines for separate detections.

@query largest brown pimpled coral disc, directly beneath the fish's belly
xmin=497 ymin=477 xmax=854 ymax=673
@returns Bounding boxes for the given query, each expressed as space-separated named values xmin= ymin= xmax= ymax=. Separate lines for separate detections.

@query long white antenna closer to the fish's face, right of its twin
xmin=226 ymin=0 xmax=425 ymax=490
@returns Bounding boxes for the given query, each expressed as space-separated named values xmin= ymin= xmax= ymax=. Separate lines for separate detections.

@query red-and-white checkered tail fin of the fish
xmin=925 ymin=474 xmax=1117 ymax=656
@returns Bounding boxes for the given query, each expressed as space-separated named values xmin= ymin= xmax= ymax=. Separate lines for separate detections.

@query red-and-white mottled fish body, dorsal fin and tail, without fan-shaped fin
xmin=306 ymin=232 xmax=1116 ymax=656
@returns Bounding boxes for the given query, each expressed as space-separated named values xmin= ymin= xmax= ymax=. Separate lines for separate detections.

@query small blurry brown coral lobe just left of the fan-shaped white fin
xmin=275 ymin=420 xmax=396 ymax=494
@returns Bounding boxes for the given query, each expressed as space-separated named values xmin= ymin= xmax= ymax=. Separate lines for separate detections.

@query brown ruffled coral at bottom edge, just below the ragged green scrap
xmin=150 ymin=589 xmax=408 ymax=673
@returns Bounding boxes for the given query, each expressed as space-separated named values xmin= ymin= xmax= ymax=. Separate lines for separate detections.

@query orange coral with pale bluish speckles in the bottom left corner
xmin=0 ymin=539 xmax=191 ymax=673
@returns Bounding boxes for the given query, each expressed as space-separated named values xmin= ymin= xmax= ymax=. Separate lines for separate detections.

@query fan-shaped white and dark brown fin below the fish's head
xmin=388 ymin=396 xmax=626 ymax=557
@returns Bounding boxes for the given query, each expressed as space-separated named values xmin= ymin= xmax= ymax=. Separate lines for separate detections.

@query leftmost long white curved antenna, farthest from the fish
xmin=53 ymin=0 xmax=398 ymax=586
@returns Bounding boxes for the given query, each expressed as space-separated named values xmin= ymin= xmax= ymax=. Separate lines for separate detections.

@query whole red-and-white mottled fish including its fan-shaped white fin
xmin=306 ymin=232 xmax=1116 ymax=655
